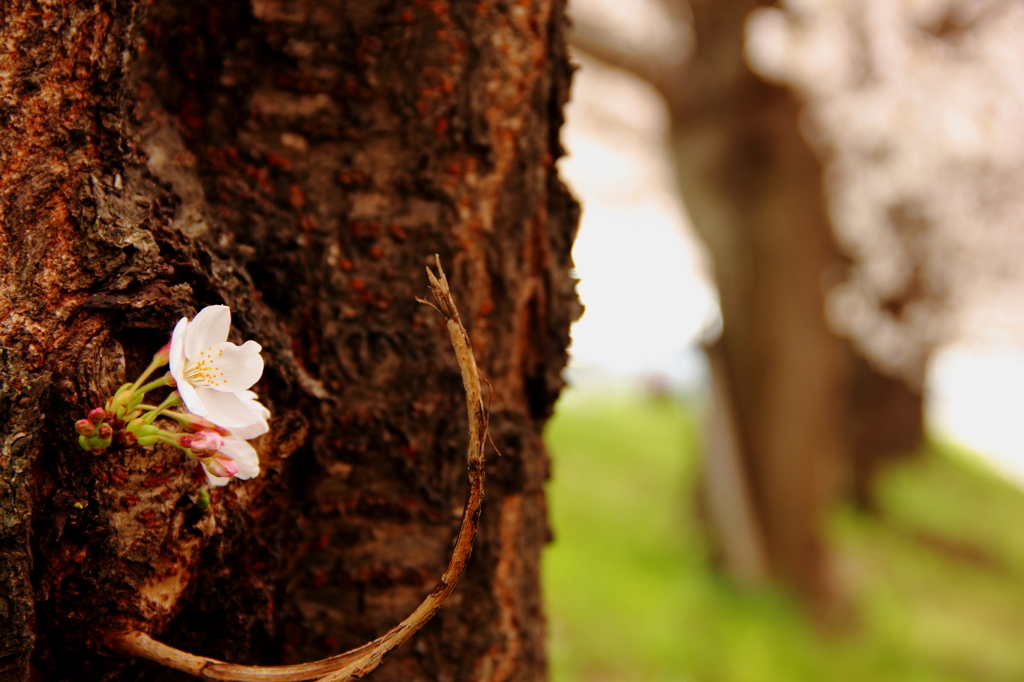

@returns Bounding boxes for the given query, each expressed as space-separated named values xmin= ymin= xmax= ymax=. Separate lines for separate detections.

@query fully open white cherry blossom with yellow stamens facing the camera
xmin=168 ymin=305 xmax=270 ymax=430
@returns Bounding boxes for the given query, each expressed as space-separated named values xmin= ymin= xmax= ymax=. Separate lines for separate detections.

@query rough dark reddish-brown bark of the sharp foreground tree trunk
xmin=0 ymin=0 xmax=579 ymax=681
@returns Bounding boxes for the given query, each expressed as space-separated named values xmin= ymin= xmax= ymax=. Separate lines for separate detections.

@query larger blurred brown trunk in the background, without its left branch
xmin=673 ymin=0 xmax=848 ymax=610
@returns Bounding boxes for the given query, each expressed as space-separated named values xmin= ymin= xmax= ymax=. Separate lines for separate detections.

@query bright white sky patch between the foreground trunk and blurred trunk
xmin=559 ymin=53 xmax=718 ymax=381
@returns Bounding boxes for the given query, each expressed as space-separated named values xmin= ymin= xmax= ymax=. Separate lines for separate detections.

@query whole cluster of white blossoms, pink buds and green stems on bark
xmin=75 ymin=305 xmax=270 ymax=485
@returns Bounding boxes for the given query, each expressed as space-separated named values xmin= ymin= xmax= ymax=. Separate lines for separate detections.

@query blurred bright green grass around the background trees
xmin=544 ymin=393 xmax=1024 ymax=682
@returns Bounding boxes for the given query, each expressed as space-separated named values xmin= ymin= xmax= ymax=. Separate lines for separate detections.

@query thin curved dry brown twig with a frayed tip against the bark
xmin=105 ymin=256 xmax=487 ymax=682
